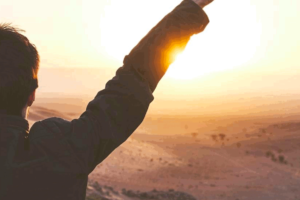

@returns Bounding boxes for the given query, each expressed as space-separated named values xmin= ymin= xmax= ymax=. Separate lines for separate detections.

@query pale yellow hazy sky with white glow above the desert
xmin=0 ymin=0 xmax=300 ymax=101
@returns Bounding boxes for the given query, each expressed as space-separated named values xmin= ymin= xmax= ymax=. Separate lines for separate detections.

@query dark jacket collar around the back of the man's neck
xmin=0 ymin=114 xmax=29 ymax=131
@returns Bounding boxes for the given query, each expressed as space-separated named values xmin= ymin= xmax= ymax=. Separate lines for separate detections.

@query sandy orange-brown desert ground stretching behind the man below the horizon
xmin=29 ymin=100 xmax=300 ymax=200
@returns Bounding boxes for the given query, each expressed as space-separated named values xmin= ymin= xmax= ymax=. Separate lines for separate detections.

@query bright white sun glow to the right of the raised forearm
xmin=166 ymin=2 xmax=262 ymax=80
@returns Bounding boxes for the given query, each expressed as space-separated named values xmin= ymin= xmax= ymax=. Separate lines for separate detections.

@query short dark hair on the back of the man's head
xmin=0 ymin=24 xmax=39 ymax=116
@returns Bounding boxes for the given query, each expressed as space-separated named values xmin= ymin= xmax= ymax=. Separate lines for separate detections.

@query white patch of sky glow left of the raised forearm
xmin=95 ymin=0 xmax=181 ymax=62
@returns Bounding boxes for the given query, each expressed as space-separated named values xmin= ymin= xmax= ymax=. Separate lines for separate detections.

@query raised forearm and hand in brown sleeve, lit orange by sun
xmin=120 ymin=0 xmax=212 ymax=92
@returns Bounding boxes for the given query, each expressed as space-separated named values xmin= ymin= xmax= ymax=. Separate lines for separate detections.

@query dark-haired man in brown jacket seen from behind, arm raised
xmin=0 ymin=0 xmax=213 ymax=200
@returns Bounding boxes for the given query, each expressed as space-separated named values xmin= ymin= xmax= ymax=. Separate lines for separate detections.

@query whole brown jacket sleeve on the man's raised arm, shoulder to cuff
xmin=70 ymin=0 xmax=208 ymax=173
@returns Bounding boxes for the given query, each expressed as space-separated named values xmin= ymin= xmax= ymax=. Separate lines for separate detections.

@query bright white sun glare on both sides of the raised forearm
xmin=95 ymin=0 xmax=261 ymax=80
